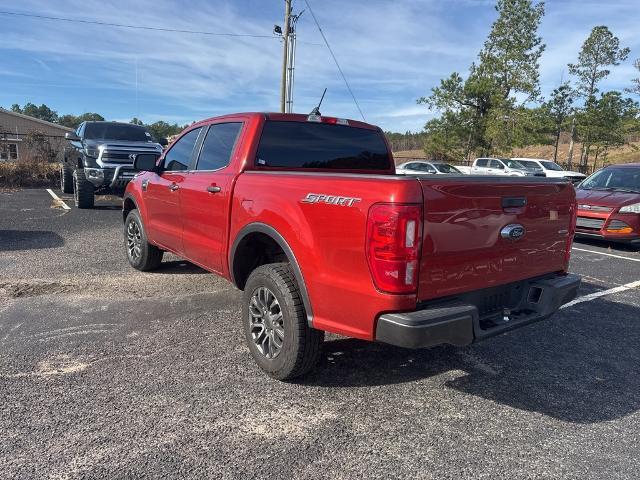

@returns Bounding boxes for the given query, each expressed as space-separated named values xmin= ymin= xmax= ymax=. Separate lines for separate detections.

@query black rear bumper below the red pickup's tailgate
xmin=376 ymin=274 xmax=580 ymax=348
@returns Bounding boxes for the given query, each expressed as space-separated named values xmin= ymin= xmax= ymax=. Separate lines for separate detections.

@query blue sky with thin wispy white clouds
xmin=0 ymin=0 xmax=640 ymax=131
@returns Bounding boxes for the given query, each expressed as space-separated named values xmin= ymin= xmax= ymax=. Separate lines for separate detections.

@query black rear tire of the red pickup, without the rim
xmin=242 ymin=263 xmax=324 ymax=380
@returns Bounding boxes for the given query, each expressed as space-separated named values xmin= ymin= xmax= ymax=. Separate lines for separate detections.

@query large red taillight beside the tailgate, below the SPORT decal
xmin=366 ymin=203 xmax=422 ymax=293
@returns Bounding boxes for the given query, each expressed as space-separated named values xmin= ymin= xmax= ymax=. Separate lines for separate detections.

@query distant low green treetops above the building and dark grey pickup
xmin=6 ymin=103 xmax=187 ymax=140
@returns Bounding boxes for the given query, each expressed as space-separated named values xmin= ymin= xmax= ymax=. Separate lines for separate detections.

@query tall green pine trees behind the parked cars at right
xmin=404 ymin=0 xmax=640 ymax=167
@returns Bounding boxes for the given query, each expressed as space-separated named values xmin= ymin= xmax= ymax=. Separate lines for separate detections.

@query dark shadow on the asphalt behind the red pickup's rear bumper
xmin=301 ymin=292 xmax=640 ymax=423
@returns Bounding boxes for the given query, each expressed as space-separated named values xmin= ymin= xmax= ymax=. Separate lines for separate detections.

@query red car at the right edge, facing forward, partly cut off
xmin=576 ymin=163 xmax=640 ymax=244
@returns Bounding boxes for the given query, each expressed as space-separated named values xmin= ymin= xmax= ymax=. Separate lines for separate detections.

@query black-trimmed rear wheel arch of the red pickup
xmin=228 ymin=223 xmax=313 ymax=326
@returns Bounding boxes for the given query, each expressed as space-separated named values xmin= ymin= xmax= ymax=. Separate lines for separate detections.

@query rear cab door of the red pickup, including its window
xmin=181 ymin=121 xmax=243 ymax=273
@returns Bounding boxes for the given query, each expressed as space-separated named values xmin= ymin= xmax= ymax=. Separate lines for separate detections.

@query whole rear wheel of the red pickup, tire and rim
xmin=242 ymin=263 xmax=324 ymax=380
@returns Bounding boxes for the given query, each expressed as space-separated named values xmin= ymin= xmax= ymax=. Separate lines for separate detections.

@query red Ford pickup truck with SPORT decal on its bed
xmin=123 ymin=113 xmax=580 ymax=379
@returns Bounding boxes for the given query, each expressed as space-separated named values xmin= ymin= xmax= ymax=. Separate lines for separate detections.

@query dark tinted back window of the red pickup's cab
xmin=255 ymin=121 xmax=391 ymax=170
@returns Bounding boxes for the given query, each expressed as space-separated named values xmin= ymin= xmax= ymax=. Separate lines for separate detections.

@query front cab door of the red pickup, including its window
xmin=142 ymin=128 xmax=202 ymax=254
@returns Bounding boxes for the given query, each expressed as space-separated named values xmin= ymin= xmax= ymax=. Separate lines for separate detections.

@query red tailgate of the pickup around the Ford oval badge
xmin=418 ymin=176 xmax=575 ymax=300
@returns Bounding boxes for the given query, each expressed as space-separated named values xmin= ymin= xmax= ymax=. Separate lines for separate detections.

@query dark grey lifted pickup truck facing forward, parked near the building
xmin=60 ymin=122 xmax=167 ymax=208
